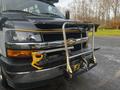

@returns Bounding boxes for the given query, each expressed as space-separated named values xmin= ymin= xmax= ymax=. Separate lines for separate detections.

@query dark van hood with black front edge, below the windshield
xmin=2 ymin=12 xmax=99 ymax=30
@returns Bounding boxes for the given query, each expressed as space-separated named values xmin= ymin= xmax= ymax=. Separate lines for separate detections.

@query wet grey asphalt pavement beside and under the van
xmin=0 ymin=37 xmax=120 ymax=90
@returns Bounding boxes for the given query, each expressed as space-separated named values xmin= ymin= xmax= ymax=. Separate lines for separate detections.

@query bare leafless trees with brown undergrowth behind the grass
xmin=70 ymin=0 xmax=120 ymax=29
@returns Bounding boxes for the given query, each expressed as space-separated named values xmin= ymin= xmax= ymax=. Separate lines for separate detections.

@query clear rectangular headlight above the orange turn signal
xmin=6 ymin=30 xmax=42 ymax=43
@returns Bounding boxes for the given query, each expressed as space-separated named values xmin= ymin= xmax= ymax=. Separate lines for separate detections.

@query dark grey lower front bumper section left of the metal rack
xmin=4 ymin=65 xmax=64 ymax=89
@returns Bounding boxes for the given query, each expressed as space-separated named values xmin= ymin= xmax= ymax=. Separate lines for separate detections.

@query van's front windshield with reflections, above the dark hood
xmin=1 ymin=0 xmax=64 ymax=18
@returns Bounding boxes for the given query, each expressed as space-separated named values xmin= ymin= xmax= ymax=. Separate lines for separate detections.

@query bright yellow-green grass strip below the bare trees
xmin=89 ymin=29 xmax=120 ymax=37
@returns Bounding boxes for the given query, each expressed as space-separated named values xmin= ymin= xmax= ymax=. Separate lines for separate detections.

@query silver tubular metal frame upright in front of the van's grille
xmin=62 ymin=22 xmax=96 ymax=77
